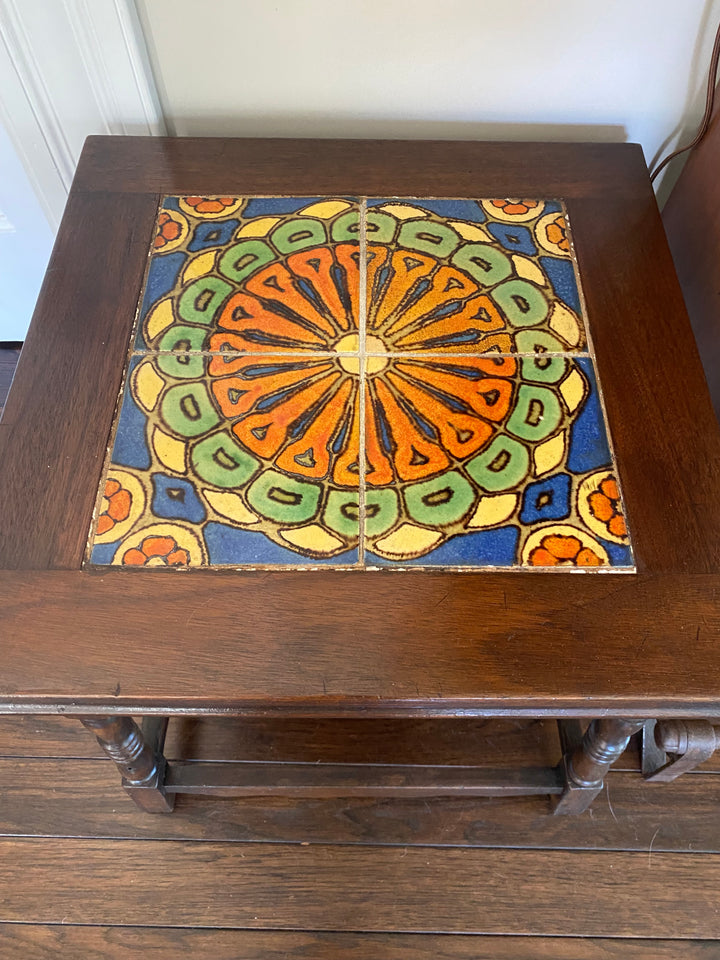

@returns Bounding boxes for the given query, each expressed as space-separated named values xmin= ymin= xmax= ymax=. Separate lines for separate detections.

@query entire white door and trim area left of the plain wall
xmin=0 ymin=0 xmax=164 ymax=340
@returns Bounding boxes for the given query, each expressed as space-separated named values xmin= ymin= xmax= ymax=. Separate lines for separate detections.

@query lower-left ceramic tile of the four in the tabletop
xmin=90 ymin=354 xmax=359 ymax=566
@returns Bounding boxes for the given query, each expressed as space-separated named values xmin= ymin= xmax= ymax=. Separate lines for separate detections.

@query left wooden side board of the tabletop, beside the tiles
xmin=0 ymin=191 xmax=157 ymax=569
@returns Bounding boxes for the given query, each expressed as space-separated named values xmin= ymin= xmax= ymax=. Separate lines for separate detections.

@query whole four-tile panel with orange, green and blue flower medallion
xmin=88 ymin=197 xmax=634 ymax=572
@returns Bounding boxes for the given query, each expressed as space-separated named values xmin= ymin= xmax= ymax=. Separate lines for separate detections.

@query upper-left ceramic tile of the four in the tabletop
xmin=135 ymin=197 xmax=360 ymax=353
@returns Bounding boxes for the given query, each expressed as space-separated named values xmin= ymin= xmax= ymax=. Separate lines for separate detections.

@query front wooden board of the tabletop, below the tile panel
xmin=0 ymin=571 xmax=720 ymax=717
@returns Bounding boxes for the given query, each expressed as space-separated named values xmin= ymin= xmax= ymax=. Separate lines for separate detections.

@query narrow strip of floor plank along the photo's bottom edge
xmin=0 ymin=924 xmax=718 ymax=960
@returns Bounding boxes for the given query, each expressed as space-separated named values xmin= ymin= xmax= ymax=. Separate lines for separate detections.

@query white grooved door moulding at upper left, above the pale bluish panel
xmin=0 ymin=0 xmax=165 ymax=231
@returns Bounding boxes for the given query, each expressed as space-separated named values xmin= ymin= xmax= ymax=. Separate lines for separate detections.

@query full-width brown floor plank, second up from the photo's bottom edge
xmin=0 ymin=838 xmax=720 ymax=939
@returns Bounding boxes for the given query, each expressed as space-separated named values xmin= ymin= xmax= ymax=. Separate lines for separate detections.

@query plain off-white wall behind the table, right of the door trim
xmin=136 ymin=0 xmax=720 ymax=199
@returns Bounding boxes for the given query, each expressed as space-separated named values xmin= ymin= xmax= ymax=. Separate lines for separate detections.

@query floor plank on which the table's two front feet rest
xmin=0 ymin=759 xmax=720 ymax=852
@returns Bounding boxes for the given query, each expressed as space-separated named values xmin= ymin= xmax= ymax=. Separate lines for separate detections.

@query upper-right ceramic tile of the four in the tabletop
xmin=365 ymin=198 xmax=587 ymax=353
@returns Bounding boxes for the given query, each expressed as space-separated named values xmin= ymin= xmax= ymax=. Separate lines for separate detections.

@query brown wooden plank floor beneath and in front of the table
xmin=0 ymin=717 xmax=720 ymax=960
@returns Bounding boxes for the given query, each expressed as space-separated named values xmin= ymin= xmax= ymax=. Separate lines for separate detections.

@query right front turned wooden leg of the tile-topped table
xmin=555 ymin=717 xmax=644 ymax=813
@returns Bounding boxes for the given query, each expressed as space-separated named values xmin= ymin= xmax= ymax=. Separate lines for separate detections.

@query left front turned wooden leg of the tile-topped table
xmin=80 ymin=717 xmax=174 ymax=813
